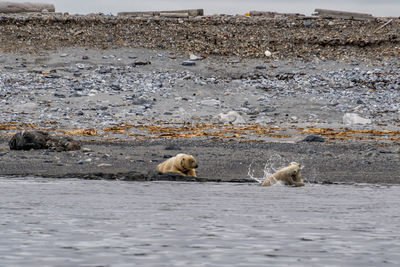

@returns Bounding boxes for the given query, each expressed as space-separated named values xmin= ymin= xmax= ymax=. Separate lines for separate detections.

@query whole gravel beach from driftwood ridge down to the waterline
xmin=0 ymin=14 xmax=400 ymax=183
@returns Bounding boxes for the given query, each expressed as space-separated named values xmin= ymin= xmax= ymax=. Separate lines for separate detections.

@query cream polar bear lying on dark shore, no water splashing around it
xmin=157 ymin=153 xmax=199 ymax=177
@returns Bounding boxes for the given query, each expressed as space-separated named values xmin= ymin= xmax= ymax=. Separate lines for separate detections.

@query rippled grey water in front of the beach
xmin=0 ymin=178 xmax=400 ymax=266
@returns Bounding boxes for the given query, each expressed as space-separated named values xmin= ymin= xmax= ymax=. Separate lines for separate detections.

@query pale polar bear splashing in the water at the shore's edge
xmin=261 ymin=162 xmax=304 ymax=186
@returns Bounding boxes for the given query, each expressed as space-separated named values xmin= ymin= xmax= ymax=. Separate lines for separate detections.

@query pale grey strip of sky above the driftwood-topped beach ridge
xmin=7 ymin=0 xmax=400 ymax=17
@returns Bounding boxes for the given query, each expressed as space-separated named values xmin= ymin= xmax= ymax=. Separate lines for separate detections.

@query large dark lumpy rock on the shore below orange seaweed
xmin=8 ymin=131 xmax=81 ymax=151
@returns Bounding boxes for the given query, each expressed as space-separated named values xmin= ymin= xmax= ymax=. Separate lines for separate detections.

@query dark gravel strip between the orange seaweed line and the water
xmin=0 ymin=138 xmax=400 ymax=184
